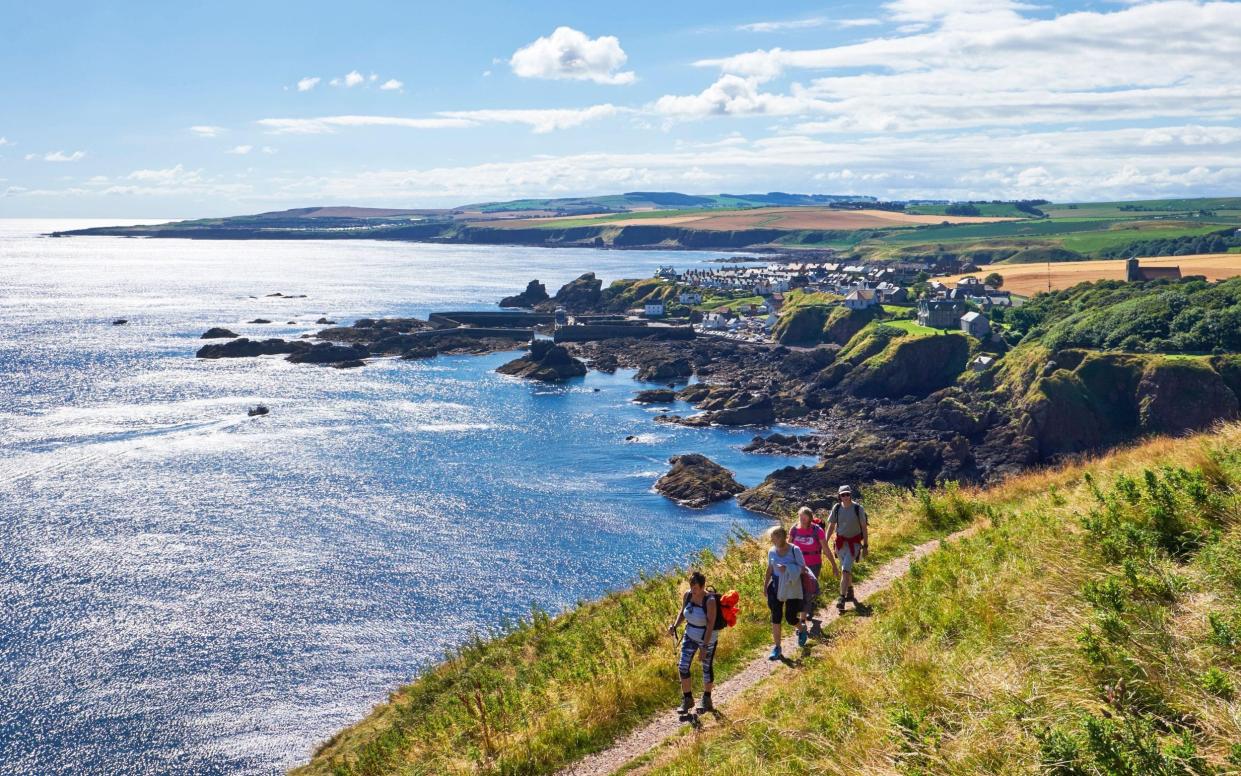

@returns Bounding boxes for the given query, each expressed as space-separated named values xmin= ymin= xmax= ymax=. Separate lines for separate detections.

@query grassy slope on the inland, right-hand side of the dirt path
xmin=630 ymin=426 xmax=1241 ymax=776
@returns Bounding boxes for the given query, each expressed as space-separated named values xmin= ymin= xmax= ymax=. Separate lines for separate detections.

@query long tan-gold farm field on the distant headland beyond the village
xmin=494 ymin=207 xmax=1015 ymax=231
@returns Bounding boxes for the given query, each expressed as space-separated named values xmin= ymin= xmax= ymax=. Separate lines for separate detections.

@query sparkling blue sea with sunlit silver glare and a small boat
xmin=0 ymin=220 xmax=810 ymax=775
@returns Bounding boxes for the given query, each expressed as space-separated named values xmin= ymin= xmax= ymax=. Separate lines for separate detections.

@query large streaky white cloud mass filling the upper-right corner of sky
xmin=680 ymin=0 xmax=1241 ymax=133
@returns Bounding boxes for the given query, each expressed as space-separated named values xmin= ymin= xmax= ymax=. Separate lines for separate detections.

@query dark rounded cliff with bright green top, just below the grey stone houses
xmin=840 ymin=334 xmax=969 ymax=399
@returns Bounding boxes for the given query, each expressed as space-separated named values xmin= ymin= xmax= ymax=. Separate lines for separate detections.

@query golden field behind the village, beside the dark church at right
xmin=934 ymin=253 xmax=1241 ymax=297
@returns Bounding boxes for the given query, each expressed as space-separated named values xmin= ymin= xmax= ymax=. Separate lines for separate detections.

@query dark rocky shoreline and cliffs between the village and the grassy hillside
xmin=186 ymin=273 xmax=1241 ymax=515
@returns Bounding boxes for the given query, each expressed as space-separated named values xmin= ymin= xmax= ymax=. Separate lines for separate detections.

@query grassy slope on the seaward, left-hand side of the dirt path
xmin=294 ymin=488 xmax=980 ymax=776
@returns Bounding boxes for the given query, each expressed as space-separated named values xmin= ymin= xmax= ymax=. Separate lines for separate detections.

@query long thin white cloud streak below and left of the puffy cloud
xmin=258 ymin=104 xmax=621 ymax=134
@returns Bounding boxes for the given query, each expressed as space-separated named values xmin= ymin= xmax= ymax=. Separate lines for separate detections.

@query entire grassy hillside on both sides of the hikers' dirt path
xmin=297 ymin=426 xmax=1241 ymax=776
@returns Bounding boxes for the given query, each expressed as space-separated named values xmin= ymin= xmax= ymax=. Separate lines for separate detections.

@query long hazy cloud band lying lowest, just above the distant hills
xmin=246 ymin=125 xmax=1241 ymax=205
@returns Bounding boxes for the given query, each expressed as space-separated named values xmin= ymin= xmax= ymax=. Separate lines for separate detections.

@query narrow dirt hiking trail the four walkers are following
xmin=557 ymin=525 xmax=978 ymax=776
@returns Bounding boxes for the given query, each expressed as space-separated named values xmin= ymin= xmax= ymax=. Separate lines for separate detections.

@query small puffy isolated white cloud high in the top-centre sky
xmin=509 ymin=27 xmax=635 ymax=84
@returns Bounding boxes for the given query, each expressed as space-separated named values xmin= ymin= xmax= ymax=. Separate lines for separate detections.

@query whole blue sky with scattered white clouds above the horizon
xmin=0 ymin=0 xmax=1241 ymax=217
